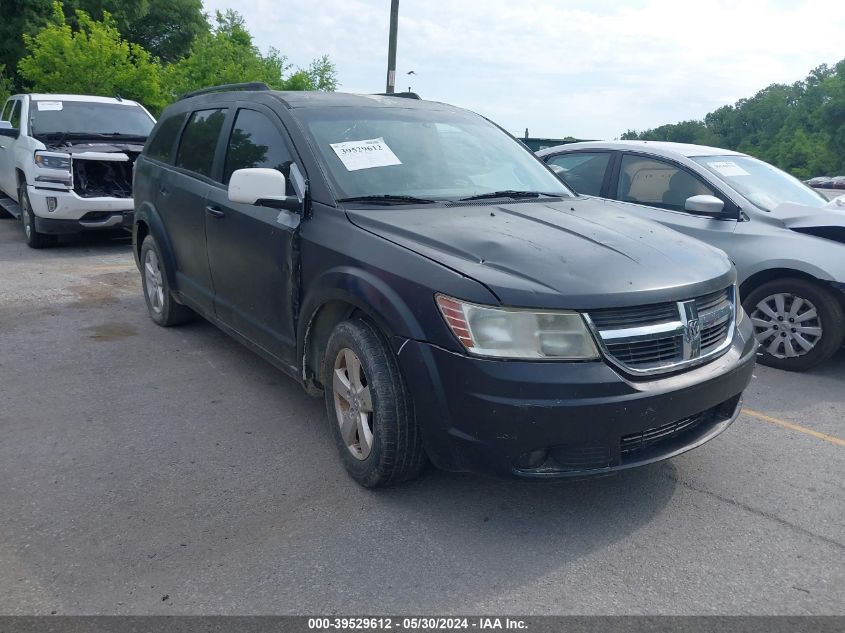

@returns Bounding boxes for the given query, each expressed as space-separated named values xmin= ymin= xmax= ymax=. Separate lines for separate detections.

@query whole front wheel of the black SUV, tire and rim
xmin=321 ymin=319 xmax=427 ymax=488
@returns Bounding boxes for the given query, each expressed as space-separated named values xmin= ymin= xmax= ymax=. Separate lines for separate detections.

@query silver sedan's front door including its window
xmin=608 ymin=152 xmax=739 ymax=252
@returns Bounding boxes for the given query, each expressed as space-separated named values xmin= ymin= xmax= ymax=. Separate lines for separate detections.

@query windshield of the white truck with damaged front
xmin=29 ymin=100 xmax=155 ymax=137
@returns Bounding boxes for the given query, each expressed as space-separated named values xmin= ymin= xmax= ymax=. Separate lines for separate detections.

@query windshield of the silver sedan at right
xmin=693 ymin=156 xmax=827 ymax=211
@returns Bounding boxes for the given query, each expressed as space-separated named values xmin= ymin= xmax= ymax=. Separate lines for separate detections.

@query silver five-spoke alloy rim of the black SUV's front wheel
xmin=332 ymin=347 xmax=374 ymax=460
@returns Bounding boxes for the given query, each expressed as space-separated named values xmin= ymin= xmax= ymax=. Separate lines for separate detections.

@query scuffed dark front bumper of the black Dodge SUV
xmin=399 ymin=318 xmax=757 ymax=478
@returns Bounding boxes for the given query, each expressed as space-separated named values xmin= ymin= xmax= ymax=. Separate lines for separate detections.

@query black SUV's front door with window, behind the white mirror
xmin=206 ymin=104 xmax=300 ymax=362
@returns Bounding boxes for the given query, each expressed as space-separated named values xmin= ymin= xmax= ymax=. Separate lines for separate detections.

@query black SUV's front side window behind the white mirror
xmin=223 ymin=110 xmax=292 ymax=188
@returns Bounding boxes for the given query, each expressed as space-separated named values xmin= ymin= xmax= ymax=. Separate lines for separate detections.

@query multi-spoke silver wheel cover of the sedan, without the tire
xmin=751 ymin=292 xmax=822 ymax=359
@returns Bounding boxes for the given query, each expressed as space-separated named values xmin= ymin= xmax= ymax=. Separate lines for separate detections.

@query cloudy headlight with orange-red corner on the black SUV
xmin=436 ymin=294 xmax=599 ymax=360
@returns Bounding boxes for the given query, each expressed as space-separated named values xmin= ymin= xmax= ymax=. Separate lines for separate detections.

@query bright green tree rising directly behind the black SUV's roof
xmin=164 ymin=10 xmax=337 ymax=98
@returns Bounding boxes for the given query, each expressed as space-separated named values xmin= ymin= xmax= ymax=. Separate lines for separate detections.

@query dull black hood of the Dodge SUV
xmin=346 ymin=198 xmax=735 ymax=309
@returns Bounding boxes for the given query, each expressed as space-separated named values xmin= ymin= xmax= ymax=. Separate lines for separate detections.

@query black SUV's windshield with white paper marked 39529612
xmin=294 ymin=107 xmax=573 ymax=202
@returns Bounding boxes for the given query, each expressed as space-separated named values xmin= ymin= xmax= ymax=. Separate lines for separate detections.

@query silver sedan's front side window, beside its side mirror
xmin=616 ymin=154 xmax=716 ymax=211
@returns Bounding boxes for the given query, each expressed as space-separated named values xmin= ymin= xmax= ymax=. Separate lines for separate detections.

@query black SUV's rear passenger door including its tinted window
xmin=163 ymin=107 xmax=228 ymax=313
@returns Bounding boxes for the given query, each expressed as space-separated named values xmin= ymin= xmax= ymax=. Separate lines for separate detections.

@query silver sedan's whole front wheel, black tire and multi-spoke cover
xmin=742 ymin=277 xmax=845 ymax=371
